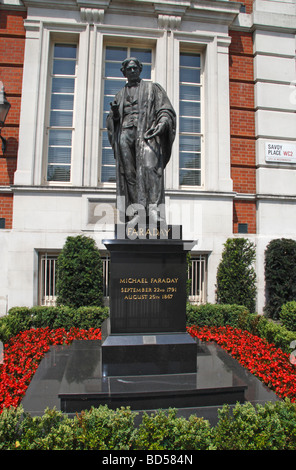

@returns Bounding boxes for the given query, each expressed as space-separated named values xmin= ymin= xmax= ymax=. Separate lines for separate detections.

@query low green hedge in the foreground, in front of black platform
xmin=0 ymin=400 xmax=296 ymax=450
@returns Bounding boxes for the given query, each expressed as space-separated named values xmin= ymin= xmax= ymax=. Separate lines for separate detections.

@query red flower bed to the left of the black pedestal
xmin=0 ymin=328 xmax=101 ymax=413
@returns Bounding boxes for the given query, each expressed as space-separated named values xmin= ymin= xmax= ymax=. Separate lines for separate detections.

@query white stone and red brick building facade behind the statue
xmin=0 ymin=0 xmax=296 ymax=315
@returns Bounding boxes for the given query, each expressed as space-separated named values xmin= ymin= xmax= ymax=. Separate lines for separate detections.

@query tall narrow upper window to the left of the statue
xmin=47 ymin=44 xmax=77 ymax=182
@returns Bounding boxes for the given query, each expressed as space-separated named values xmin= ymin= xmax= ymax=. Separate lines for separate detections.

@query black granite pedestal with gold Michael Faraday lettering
xmin=102 ymin=238 xmax=196 ymax=376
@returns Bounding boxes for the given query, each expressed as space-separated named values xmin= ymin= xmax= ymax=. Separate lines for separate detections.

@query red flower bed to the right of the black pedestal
xmin=188 ymin=326 xmax=296 ymax=402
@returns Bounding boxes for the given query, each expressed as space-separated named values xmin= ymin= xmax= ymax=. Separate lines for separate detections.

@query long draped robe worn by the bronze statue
xmin=107 ymin=80 xmax=176 ymax=219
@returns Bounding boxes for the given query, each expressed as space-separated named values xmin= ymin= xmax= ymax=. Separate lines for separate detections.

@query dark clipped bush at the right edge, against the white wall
xmin=265 ymin=238 xmax=296 ymax=319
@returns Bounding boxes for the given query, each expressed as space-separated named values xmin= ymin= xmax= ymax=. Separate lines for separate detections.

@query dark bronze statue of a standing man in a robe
xmin=107 ymin=57 xmax=176 ymax=222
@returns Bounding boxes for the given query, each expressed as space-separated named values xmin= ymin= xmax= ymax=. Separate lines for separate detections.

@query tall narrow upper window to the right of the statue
xmin=179 ymin=52 xmax=201 ymax=186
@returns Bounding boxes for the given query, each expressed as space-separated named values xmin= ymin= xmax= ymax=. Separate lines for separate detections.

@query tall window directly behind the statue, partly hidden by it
xmin=101 ymin=46 xmax=152 ymax=183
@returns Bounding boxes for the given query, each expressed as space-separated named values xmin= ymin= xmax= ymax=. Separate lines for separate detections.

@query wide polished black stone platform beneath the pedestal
xmin=22 ymin=340 xmax=278 ymax=424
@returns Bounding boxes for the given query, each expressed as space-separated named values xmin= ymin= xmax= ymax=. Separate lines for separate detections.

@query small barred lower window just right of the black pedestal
xmin=188 ymin=255 xmax=207 ymax=304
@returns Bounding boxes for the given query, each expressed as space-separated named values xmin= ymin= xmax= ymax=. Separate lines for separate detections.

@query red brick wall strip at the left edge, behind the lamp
xmin=0 ymin=10 xmax=26 ymax=228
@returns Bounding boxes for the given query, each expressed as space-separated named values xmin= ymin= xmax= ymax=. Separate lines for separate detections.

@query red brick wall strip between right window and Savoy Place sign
xmin=229 ymin=28 xmax=256 ymax=233
